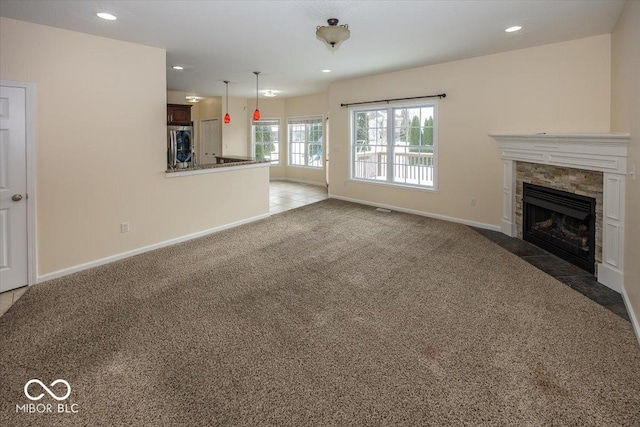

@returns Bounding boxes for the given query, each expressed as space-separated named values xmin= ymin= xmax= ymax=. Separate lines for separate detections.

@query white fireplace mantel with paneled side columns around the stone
xmin=490 ymin=133 xmax=629 ymax=292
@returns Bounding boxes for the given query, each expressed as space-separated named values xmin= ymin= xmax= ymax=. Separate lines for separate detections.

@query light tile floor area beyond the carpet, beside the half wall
xmin=269 ymin=181 xmax=328 ymax=213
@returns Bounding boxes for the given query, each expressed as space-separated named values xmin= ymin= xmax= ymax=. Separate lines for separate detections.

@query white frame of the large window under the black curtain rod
xmin=349 ymin=100 xmax=439 ymax=192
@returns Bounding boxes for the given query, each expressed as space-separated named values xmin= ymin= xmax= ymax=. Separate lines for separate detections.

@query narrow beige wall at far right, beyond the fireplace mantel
xmin=611 ymin=1 xmax=640 ymax=336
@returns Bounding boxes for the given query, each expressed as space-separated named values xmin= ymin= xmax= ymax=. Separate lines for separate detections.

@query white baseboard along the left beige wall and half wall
xmin=36 ymin=213 xmax=271 ymax=283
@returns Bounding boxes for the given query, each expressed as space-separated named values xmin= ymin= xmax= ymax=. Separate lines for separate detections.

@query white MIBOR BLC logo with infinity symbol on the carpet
xmin=16 ymin=378 xmax=78 ymax=414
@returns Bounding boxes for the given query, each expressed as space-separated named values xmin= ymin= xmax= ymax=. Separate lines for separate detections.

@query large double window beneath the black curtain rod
xmin=351 ymin=103 xmax=437 ymax=189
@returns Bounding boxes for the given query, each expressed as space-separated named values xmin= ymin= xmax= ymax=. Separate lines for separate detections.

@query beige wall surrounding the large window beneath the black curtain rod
xmin=329 ymin=35 xmax=611 ymax=226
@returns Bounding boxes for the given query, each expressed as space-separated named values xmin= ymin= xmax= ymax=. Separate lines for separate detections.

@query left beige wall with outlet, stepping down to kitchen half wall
xmin=0 ymin=18 xmax=269 ymax=275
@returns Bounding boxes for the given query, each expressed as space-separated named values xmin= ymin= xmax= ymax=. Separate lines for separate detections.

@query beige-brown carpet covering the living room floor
xmin=0 ymin=200 xmax=640 ymax=426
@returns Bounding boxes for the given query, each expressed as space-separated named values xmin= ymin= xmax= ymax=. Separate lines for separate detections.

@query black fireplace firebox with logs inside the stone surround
xmin=522 ymin=182 xmax=596 ymax=273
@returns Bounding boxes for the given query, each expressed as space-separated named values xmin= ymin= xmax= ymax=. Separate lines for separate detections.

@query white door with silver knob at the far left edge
xmin=0 ymin=86 xmax=28 ymax=292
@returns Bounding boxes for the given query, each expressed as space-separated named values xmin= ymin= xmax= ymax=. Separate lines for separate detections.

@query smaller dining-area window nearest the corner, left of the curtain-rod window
xmin=288 ymin=116 xmax=323 ymax=168
